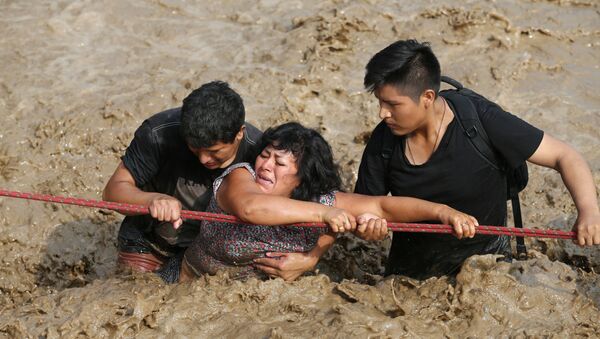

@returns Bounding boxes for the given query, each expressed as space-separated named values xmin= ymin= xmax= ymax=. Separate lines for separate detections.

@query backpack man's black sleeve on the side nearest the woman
xmin=354 ymin=122 xmax=389 ymax=195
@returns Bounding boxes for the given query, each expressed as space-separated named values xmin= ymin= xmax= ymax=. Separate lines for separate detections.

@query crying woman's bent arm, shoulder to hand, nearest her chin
xmin=216 ymin=168 xmax=356 ymax=232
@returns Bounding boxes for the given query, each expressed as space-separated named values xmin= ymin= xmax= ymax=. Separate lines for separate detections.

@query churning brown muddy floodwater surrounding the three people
xmin=0 ymin=0 xmax=600 ymax=338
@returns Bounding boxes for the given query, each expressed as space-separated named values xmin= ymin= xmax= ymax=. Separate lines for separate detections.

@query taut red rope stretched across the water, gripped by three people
xmin=0 ymin=189 xmax=577 ymax=239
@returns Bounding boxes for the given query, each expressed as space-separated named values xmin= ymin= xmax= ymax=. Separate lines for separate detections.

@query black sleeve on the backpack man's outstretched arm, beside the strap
xmin=479 ymin=99 xmax=544 ymax=168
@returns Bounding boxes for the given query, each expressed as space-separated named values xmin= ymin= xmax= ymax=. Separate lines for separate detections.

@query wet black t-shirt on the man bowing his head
xmin=121 ymin=108 xmax=262 ymax=246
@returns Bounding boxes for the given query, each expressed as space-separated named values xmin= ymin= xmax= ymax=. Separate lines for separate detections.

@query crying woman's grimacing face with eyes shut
xmin=254 ymin=145 xmax=300 ymax=197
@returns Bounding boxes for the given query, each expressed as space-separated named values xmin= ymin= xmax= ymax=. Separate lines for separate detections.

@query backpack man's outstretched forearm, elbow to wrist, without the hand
xmin=555 ymin=151 xmax=599 ymax=214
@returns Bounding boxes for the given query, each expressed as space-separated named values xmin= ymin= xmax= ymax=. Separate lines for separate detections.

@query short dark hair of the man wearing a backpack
xmin=364 ymin=40 xmax=441 ymax=102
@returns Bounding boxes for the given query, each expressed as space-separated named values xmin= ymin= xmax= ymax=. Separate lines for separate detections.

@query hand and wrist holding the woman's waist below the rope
xmin=254 ymin=233 xmax=335 ymax=281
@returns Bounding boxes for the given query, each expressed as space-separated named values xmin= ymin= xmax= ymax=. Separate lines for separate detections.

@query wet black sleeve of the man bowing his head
xmin=121 ymin=120 xmax=161 ymax=187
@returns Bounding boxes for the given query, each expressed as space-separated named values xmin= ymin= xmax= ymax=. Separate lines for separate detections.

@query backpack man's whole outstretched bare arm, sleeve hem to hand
xmin=528 ymin=134 xmax=600 ymax=246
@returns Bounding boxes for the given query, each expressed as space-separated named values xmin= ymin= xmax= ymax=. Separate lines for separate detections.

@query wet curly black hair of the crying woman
xmin=261 ymin=122 xmax=341 ymax=201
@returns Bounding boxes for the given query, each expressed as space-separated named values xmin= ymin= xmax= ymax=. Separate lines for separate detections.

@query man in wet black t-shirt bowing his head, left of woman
xmin=103 ymin=81 xmax=262 ymax=271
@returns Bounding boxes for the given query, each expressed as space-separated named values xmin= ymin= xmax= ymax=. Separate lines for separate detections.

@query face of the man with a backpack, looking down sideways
xmin=374 ymin=85 xmax=426 ymax=135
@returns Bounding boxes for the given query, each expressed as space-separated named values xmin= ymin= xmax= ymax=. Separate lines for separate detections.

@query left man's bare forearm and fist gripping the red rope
xmin=102 ymin=162 xmax=183 ymax=228
